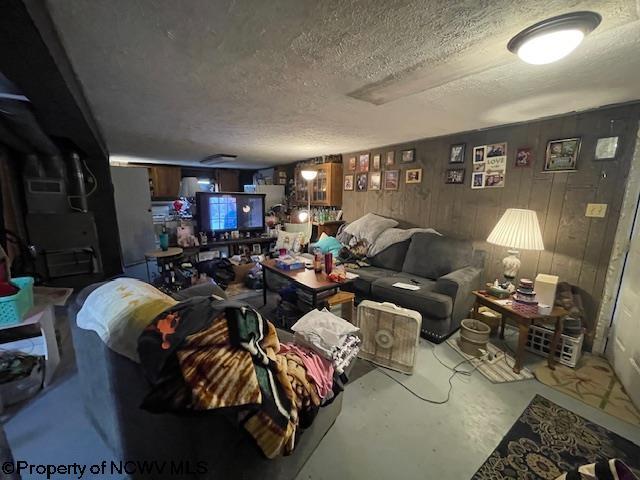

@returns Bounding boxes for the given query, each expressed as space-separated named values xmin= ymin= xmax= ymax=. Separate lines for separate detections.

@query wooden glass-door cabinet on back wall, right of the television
xmin=296 ymin=163 xmax=342 ymax=207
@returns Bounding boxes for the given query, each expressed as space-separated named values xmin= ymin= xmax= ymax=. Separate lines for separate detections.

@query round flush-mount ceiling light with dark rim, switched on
xmin=507 ymin=12 xmax=602 ymax=65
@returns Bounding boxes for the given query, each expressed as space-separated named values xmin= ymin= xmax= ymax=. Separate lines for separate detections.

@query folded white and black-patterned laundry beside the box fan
xmin=291 ymin=309 xmax=360 ymax=382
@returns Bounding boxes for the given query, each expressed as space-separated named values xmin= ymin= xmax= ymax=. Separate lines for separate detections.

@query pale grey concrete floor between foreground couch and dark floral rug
xmin=298 ymin=335 xmax=640 ymax=480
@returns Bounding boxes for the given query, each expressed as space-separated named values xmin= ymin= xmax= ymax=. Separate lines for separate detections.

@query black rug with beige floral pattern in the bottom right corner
xmin=473 ymin=395 xmax=640 ymax=480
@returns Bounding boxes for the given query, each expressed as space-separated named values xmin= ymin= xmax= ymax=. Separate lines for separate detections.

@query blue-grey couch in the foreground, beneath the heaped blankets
xmin=69 ymin=284 xmax=342 ymax=480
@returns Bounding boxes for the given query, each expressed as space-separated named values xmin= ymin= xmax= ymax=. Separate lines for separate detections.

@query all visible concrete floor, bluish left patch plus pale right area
xmin=5 ymin=310 xmax=640 ymax=480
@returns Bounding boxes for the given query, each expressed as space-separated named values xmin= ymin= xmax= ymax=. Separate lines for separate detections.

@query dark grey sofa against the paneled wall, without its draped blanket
xmin=351 ymin=233 xmax=486 ymax=343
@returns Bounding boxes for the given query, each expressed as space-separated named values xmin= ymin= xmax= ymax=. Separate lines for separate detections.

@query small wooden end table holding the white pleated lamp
xmin=473 ymin=290 xmax=569 ymax=373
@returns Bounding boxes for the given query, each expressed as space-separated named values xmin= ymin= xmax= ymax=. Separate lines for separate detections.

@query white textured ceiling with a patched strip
xmin=47 ymin=0 xmax=640 ymax=166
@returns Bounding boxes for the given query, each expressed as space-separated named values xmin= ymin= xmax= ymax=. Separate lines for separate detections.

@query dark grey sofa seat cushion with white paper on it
xmin=371 ymin=273 xmax=453 ymax=319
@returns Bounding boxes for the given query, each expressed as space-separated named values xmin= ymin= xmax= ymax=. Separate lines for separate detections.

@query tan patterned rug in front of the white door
xmin=535 ymin=354 xmax=640 ymax=426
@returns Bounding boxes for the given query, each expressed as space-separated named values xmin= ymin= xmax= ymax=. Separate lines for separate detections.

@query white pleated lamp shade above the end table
xmin=487 ymin=208 xmax=544 ymax=250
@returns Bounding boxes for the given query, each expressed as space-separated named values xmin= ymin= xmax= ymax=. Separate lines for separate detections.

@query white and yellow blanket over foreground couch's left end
xmin=76 ymin=278 xmax=178 ymax=363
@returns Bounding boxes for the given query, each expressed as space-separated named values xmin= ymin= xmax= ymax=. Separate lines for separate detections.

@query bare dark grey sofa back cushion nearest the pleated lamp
xmin=402 ymin=233 xmax=473 ymax=280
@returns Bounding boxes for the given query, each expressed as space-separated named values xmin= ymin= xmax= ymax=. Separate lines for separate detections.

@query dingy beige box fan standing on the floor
xmin=356 ymin=300 xmax=422 ymax=374
